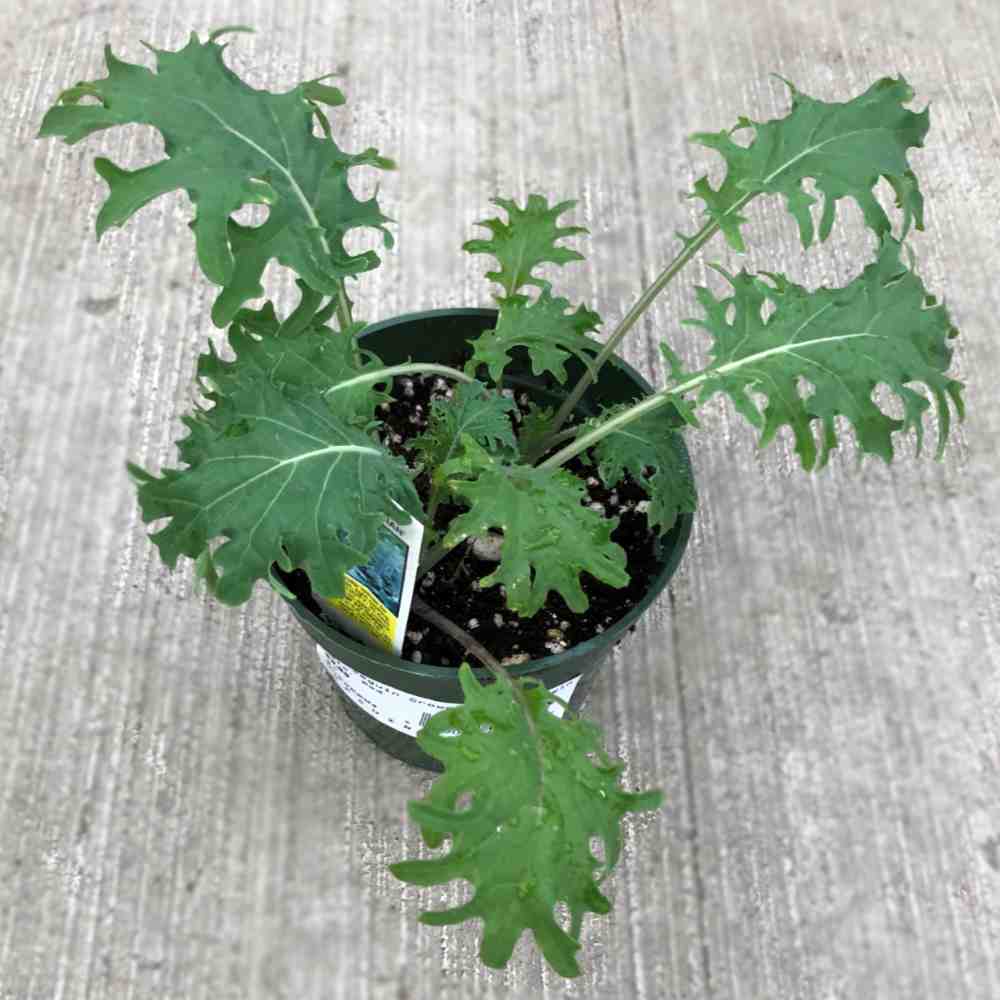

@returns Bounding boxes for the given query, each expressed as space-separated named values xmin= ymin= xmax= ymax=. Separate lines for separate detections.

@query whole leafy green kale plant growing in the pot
xmin=40 ymin=28 xmax=963 ymax=976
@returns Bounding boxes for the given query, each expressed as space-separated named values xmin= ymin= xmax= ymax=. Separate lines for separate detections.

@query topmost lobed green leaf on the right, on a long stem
xmin=681 ymin=76 xmax=929 ymax=251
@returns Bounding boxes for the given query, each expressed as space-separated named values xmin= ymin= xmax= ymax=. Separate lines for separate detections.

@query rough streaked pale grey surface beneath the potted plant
xmin=0 ymin=0 xmax=1000 ymax=1000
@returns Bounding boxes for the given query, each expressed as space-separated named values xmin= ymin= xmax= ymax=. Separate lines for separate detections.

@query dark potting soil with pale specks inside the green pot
xmin=288 ymin=375 xmax=662 ymax=667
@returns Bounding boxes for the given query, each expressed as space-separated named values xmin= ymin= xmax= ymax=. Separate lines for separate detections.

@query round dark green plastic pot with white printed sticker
xmin=272 ymin=309 xmax=693 ymax=771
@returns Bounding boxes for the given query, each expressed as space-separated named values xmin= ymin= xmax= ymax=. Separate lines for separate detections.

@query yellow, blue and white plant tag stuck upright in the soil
xmin=326 ymin=504 xmax=424 ymax=656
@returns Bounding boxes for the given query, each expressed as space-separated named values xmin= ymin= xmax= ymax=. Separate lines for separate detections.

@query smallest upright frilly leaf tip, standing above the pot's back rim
xmin=462 ymin=194 xmax=590 ymax=297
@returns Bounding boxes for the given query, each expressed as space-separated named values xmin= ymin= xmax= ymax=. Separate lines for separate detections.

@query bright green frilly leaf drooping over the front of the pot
xmin=390 ymin=664 xmax=663 ymax=977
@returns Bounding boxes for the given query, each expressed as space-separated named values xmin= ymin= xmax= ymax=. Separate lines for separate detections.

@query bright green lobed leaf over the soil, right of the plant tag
xmin=442 ymin=435 xmax=629 ymax=618
